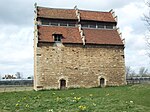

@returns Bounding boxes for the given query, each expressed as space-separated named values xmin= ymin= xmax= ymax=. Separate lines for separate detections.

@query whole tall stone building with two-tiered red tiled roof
xmin=34 ymin=6 xmax=126 ymax=90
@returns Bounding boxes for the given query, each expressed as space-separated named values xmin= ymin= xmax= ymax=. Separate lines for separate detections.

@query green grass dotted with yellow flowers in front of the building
xmin=0 ymin=85 xmax=150 ymax=112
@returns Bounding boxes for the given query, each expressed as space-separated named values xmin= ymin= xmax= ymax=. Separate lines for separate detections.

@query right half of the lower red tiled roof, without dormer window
xmin=83 ymin=29 xmax=123 ymax=45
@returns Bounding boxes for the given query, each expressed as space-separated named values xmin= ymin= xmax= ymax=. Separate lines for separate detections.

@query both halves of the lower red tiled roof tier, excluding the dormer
xmin=38 ymin=26 xmax=123 ymax=45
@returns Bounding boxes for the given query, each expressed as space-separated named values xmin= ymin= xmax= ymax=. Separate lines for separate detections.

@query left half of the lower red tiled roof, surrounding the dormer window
xmin=38 ymin=26 xmax=82 ymax=43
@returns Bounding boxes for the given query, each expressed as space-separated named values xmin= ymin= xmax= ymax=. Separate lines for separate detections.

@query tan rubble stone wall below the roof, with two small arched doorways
xmin=35 ymin=43 xmax=126 ymax=90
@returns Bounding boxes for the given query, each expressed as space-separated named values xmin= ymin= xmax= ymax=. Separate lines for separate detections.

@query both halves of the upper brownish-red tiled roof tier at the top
xmin=38 ymin=7 xmax=116 ymax=22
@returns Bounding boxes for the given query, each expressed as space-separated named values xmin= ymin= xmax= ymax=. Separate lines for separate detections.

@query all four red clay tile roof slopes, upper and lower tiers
xmin=38 ymin=7 xmax=124 ymax=45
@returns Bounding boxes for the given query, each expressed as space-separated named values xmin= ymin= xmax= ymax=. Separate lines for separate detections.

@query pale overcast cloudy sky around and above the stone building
xmin=0 ymin=0 xmax=150 ymax=77
